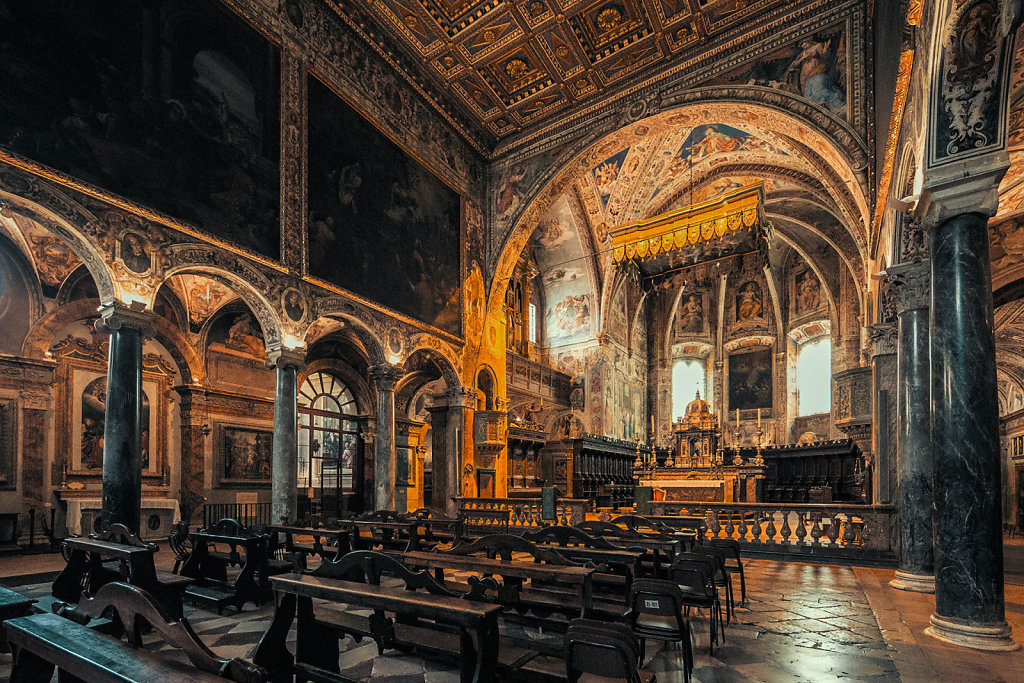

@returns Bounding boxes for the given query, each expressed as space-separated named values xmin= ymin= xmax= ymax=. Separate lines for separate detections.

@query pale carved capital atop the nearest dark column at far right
xmin=914 ymin=156 xmax=1010 ymax=222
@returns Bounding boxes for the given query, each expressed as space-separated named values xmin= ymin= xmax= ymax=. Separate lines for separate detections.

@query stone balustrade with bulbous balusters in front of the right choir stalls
xmin=650 ymin=501 xmax=896 ymax=563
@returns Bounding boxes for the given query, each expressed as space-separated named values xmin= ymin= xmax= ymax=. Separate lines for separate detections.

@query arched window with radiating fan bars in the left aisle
xmin=297 ymin=372 xmax=359 ymax=512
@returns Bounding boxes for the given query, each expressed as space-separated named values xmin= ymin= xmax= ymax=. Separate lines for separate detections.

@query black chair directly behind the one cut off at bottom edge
xmin=629 ymin=579 xmax=693 ymax=681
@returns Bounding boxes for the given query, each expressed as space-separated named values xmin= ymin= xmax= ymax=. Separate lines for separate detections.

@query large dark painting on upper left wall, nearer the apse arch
xmin=309 ymin=77 xmax=462 ymax=336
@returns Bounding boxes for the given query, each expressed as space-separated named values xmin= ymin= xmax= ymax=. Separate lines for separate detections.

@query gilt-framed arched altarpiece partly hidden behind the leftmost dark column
xmin=53 ymin=337 xmax=174 ymax=477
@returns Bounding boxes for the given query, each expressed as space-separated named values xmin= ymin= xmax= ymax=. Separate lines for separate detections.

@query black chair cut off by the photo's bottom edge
xmin=565 ymin=618 xmax=653 ymax=683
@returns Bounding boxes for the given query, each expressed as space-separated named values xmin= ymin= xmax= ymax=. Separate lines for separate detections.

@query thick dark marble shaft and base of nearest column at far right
xmin=927 ymin=213 xmax=1017 ymax=650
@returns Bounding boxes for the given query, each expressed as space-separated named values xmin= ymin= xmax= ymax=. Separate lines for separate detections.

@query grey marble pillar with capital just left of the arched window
xmin=266 ymin=348 xmax=305 ymax=524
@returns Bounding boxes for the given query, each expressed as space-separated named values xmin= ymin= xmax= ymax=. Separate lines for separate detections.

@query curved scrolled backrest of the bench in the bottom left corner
xmin=68 ymin=582 xmax=269 ymax=683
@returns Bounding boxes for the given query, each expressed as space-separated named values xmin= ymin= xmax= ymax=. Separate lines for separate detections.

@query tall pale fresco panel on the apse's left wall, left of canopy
xmin=531 ymin=197 xmax=593 ymax=346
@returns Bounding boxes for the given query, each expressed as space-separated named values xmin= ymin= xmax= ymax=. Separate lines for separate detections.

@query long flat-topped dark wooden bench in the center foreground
xmin=254 ymin=574 xmax=501 ymax=683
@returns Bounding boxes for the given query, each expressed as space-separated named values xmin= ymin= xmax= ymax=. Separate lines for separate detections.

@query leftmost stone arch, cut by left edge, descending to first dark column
xmin=0 ymin=176 xmax=121 ymax=303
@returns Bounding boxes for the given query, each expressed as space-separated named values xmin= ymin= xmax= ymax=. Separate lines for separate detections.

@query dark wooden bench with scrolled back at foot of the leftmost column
xmin=51 ymin=524 xmax=191 ymax=618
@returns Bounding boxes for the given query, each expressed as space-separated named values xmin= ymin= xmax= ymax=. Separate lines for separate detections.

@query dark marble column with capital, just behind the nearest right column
xmin=886 ymin=260 xmax=935 ymax=593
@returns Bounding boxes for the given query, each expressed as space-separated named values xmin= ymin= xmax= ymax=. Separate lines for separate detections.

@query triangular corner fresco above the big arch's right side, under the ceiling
xmin=710 ymin=27 xmax=849 ymax=120
